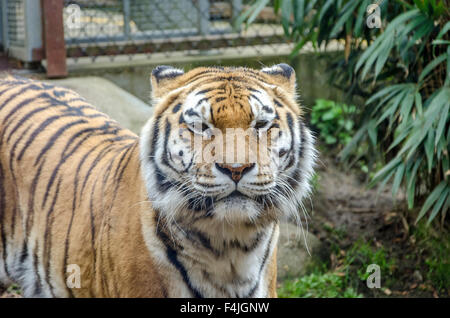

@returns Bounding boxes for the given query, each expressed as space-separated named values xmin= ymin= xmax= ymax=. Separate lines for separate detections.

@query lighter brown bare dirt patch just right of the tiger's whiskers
xmin=311 ymin=155 xmax=402 ymax=239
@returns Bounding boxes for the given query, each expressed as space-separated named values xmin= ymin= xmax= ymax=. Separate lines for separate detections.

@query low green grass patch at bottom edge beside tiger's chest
xmin=278 ymin=273 xmax=362 ymax=298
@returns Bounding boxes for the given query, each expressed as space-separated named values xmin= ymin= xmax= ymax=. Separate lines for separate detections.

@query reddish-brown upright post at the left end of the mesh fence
xmin=42 ymin=0 xmax=67 ymax=78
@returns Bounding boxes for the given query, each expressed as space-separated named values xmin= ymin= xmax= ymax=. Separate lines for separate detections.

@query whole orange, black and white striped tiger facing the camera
xmin=0 ymin=64 xmax=317 ymax=298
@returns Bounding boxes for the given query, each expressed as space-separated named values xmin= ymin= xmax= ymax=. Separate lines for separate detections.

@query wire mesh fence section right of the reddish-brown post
xmin=63 ymin=0 xmax=291 ymax=61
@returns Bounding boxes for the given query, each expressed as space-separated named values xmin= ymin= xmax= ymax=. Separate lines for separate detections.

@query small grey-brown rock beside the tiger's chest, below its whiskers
xmin=277 ymin=223 xmax=321 ymax=280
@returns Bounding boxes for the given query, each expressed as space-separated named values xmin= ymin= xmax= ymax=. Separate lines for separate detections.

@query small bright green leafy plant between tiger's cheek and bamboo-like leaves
xmin=311 ymin=99 xmax=356 ymax=145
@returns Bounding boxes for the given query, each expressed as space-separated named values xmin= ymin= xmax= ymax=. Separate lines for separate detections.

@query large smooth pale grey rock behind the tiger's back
xmin=45 ymin=76 xmax=153 ymax=134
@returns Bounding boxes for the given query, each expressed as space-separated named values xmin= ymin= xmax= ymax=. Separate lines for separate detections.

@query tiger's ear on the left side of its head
xmin=151 ymin=65 xmax=184 ymax=98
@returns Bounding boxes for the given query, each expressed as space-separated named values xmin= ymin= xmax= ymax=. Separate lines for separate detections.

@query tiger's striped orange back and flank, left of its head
xmin=0 ymin=77 xmax=164 ymax=297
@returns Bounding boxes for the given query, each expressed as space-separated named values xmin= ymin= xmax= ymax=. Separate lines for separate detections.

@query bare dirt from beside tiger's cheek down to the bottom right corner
xmin=309 ymin=155 xmax=444 ymax=298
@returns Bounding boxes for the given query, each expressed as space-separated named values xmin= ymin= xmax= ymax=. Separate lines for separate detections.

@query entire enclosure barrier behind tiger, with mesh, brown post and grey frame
xmin=0 ymin=0 xmax=290 ymax=76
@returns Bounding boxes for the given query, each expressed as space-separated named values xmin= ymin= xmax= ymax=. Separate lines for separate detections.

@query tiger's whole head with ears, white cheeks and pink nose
xmin=141 ymin=64 xmax=315 ymax=223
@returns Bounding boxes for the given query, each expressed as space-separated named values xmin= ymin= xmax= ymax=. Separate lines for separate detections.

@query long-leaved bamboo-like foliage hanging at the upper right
xmin=242 ymin=0 xmax=450 ymax=224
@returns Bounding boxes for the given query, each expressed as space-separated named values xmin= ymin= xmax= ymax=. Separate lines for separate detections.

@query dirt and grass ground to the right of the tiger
xmin=279 ymin=150 xmax=450 ymax=297
